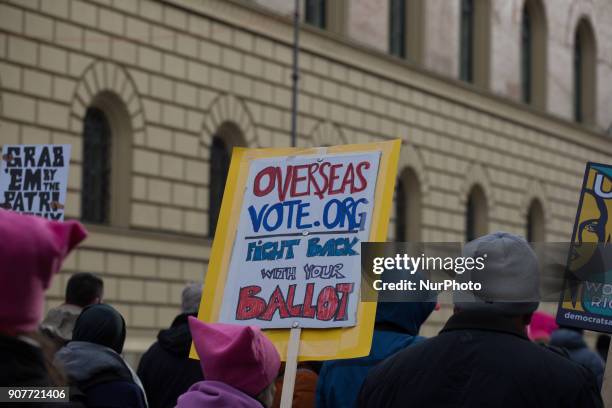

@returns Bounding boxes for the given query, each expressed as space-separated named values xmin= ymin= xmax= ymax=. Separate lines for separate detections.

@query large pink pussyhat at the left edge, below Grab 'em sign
xmin=0 ymin=210 xmax=87 ymax=335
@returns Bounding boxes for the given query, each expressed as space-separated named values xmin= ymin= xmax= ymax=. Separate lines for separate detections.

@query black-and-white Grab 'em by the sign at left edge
xmin=0 ymin=145 xmax=70 ymax=221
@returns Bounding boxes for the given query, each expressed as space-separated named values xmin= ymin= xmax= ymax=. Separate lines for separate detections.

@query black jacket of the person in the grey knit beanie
xmin=358 ymin=311 xmax=603 ymax=408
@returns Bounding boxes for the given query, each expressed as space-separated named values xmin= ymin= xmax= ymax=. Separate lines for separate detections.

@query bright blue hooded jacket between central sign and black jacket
xmin=317 ymin=302 xmax=435 ymax=408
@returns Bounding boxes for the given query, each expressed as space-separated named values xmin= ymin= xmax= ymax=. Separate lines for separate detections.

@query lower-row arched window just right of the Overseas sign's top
xmin=395 ymin=169 xmax=421 ymax=242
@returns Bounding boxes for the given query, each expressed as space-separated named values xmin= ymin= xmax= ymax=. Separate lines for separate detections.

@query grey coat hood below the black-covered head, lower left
xmin=54 ymin=341 xmax=133 ymax=383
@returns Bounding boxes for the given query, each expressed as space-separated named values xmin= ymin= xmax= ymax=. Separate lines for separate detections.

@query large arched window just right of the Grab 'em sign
xmin=81 ymin=91 xmax=132 ymax=227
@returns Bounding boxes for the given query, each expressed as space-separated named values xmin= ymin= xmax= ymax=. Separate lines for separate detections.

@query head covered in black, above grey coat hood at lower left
xmin=72 ymin=304 xmax=126 ymax=354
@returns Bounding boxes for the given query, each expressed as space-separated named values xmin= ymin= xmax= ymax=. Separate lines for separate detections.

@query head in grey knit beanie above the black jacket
xmin=454 ymin=232 xmax=540 ymax=326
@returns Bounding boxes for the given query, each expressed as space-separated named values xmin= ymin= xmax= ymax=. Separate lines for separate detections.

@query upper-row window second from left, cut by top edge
xmin=389 ymin=0 xmax=424 ymax=62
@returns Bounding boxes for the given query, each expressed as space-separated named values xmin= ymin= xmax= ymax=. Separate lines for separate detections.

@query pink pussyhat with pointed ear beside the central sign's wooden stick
xmin=189 ymin=316 xmax=280 ymax=397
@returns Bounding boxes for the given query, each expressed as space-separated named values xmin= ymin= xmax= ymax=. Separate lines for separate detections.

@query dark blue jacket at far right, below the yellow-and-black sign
xmin=550 ymin=328 xmax=605 ymax=389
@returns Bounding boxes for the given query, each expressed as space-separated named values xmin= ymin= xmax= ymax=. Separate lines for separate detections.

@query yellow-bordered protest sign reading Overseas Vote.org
xmin=192 ymin=141 xmax=400 ymax=361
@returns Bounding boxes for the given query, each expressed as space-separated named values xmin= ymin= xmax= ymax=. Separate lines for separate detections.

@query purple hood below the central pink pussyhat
xmin=176 ymin=381 xmax=262 ymax=408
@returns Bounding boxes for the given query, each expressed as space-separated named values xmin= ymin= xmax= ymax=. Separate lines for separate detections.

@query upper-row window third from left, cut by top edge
xmin=459 ymin=0 xmax=491 ymax=87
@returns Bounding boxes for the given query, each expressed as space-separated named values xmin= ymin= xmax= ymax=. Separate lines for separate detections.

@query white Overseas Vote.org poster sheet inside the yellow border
xmin=220 ymin=151 xmax=380 ymax=328
